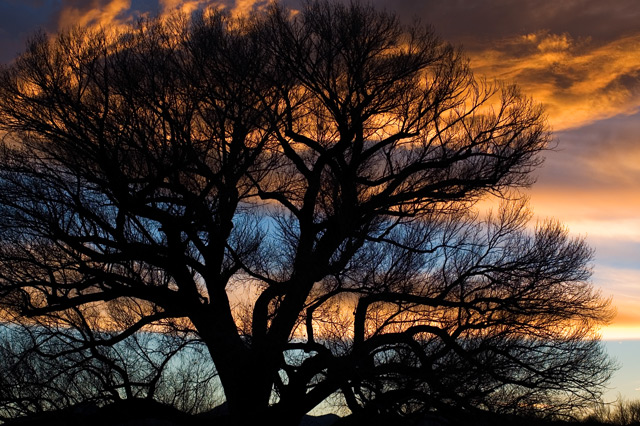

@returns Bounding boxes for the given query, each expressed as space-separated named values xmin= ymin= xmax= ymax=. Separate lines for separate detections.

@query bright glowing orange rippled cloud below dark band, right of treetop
xmin=470 ymin=31 xmax=640 ymax=130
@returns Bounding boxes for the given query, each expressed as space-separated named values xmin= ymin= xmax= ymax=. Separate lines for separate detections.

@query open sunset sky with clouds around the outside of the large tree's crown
xmin=0 ymin=0 xmax=640 ymax=396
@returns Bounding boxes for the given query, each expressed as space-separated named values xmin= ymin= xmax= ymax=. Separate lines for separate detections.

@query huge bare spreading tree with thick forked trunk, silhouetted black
xmin=0 ymin=2 xmax=609 ymax=424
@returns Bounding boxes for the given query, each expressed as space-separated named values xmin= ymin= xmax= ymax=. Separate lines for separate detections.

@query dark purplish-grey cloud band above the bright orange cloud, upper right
xmin=374 ymin=0 xmax=640 ymax=49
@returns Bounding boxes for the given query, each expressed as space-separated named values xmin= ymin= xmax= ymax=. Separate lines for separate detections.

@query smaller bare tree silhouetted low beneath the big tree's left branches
xmin=0 ymin=300 xmax=220 ymax=420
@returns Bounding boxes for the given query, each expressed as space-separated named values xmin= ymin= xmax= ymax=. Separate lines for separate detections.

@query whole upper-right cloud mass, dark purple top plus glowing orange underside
xmin=368 ymin=0 xmax=640 ymax=131
